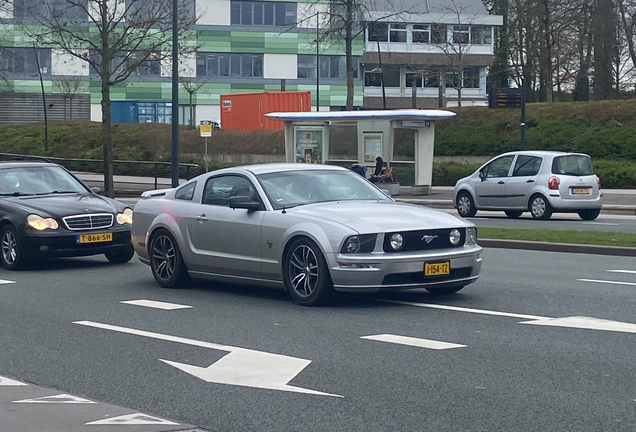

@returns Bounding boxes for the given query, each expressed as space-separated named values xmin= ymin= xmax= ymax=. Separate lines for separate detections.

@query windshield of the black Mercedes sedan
xmin=0 ymin=166 xmax=88 ymax=196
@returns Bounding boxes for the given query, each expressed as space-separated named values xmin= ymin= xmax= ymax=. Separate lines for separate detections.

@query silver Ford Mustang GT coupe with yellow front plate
xmin=132 ymin=164 xmax=482 ymax=306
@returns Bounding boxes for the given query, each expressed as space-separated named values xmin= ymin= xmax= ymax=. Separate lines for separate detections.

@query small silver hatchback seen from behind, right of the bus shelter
xmin=453 ymin=151 xmax=603 ymax=220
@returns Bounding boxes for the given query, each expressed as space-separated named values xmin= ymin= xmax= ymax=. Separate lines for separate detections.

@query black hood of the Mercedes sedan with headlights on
xmin=4 ymin=194 xmax=123 ymax=217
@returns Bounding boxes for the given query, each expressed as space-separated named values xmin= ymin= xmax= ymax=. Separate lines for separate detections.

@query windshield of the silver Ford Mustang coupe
xmin=258 ymin=170 xmax=390 ymax=209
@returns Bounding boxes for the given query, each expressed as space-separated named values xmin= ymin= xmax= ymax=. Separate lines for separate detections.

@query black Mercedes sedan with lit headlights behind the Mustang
xmin=0 ymin=161 xmax=135 ymax=270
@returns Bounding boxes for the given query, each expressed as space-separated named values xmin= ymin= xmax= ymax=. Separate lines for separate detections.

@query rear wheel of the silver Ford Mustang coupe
xmin=150 ymin=229 xmax=190 ymax=288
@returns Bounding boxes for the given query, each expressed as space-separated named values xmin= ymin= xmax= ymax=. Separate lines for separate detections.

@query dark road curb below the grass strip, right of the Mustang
xmin=477 ymin=238 xmax=636 ymax=257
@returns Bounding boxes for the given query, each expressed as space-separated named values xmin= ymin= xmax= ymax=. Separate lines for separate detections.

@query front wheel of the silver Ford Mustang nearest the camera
xmin=283 ymin=238 xmax=334 ymax=306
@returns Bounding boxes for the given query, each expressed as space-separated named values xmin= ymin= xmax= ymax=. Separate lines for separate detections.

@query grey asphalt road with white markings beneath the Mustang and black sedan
xmin=0 ymin=249 xmax=636 ymax=432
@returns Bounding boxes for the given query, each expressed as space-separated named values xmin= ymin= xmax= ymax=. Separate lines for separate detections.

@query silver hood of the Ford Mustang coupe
xmin=288 ymin=201 xmax=474 ymax=234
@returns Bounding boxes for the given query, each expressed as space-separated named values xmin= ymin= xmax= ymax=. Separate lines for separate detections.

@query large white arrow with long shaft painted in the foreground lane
xmin=73 ymin=321 xmax=343 ymax=397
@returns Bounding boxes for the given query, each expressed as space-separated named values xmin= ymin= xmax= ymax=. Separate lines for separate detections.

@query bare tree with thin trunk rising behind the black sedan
xmin=13 ymin=0 xmax=197 ymax=196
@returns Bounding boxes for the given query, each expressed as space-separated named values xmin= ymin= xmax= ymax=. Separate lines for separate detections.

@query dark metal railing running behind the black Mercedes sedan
xmin=0 ymin=153 xmax=198 ymax=189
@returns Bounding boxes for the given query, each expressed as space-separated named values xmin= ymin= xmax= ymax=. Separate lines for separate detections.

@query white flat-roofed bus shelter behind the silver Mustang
xmin=265 ymin=109 xmax=455 ymax=194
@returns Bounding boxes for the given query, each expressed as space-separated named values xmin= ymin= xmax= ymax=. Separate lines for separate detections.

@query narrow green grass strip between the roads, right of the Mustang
xmin=477 ymin=227 xmax=636 ymax=247
